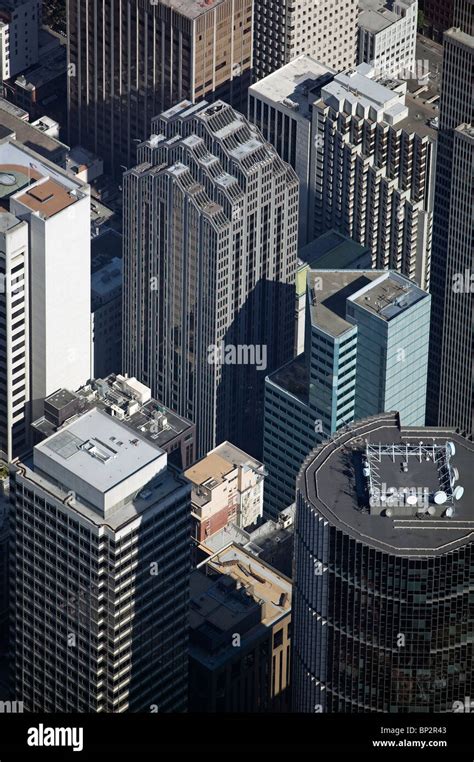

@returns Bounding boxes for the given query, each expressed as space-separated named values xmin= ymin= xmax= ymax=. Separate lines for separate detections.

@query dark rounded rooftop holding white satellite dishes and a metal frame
xmin=298 ymin=413 xmax=474 ymax=557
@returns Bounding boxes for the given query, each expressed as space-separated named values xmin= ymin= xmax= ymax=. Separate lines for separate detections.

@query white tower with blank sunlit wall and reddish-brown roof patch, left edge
xmin=0 ymin=138 xmax=91 ymax=459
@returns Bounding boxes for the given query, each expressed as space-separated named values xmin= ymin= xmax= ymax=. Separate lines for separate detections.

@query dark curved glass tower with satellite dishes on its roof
xmin=292 ymin=413 xmax=474 ymax=713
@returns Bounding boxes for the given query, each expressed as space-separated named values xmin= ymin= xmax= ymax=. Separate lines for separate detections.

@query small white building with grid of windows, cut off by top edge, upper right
xmin=357 ymin=0 xmax=418 ymax=78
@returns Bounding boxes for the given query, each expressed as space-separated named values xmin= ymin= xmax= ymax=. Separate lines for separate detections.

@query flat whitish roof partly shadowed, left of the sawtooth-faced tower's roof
xmin=249 ymin=54 xmax=336 ymax=118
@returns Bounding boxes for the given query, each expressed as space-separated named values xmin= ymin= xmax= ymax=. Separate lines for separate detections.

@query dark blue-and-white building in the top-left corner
xmin=0 ymin=0 xmax=41 ymax=81
